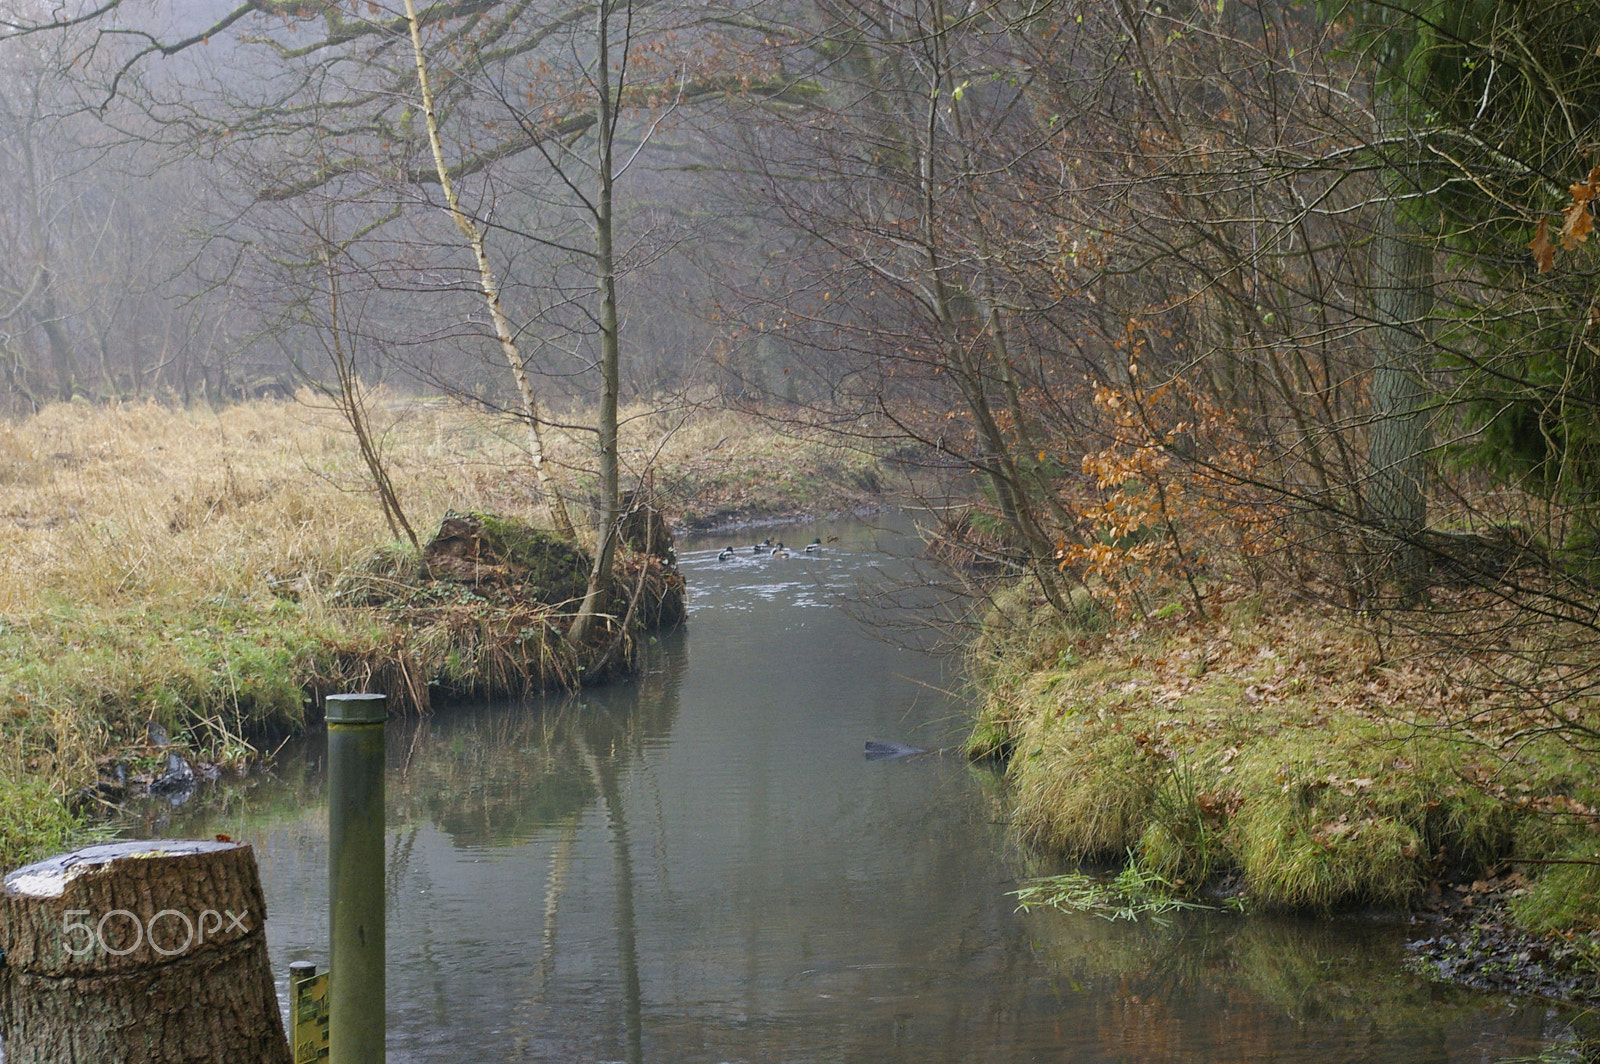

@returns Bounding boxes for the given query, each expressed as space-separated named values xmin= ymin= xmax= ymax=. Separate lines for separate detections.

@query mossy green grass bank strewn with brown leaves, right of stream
xmin=970 ymin=590 xmax=1600 ymax=930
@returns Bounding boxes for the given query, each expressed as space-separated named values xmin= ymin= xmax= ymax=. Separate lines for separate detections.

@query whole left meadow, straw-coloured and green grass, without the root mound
xmin=0 ymin=397 xmax=880 ymax=869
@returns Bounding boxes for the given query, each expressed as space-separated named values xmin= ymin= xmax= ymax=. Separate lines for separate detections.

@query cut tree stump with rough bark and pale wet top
xmin=0 ymin=840 xmax=290 ymax=1064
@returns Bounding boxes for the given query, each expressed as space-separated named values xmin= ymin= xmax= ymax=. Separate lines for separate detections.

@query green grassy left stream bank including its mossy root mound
xmin=0 ymin=514 xmax=683 ymax=867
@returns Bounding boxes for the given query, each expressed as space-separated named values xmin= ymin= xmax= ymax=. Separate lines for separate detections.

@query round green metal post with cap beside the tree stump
xmin=328 ymin=694 xmax=389 ymax=1064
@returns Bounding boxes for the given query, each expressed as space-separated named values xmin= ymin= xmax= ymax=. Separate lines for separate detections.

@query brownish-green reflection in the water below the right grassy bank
xmin=1011 ymin=914 xmax=1570 ymax=1064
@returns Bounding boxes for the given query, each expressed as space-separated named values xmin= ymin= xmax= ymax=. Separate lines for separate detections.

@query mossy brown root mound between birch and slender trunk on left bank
xmin=422 ymin=510 xmax=594 ymax=606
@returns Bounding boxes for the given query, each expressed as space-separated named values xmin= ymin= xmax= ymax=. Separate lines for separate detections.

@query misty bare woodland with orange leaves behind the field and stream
xmin=9 ymin=0 xmax=1600 ymax=832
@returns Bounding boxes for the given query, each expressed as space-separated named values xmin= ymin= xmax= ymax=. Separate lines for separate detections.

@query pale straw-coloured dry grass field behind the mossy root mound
xmin=0 ymin=395 xmax=882 ymax=614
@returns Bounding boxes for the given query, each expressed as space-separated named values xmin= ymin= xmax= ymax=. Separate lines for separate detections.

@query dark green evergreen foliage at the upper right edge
xmin=1325 ymin=0 xmax=1600 ymax=531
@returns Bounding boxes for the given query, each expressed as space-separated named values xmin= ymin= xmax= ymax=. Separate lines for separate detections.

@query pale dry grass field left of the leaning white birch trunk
xmin=0 ymin=392 xmax=505 ymax=613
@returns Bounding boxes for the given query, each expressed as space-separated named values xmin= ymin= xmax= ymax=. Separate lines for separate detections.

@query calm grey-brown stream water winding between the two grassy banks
xmin=121 ymin=523 xmax=1565 ymax=1064
